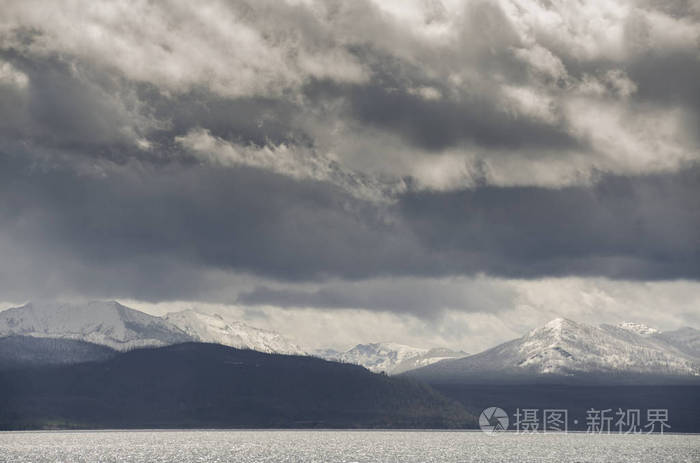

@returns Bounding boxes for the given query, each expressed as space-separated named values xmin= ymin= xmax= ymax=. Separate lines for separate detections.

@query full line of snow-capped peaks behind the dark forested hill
xmin=0 ymin=301 xmax=700 ymax=383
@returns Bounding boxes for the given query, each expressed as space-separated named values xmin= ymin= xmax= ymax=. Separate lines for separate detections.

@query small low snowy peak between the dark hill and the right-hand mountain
xmin=315 ymin=342 xmax=467 ymax=374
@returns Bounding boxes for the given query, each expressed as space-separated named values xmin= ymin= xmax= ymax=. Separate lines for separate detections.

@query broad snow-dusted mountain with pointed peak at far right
xmin=404 ymin=318 xmax=700 ymax=380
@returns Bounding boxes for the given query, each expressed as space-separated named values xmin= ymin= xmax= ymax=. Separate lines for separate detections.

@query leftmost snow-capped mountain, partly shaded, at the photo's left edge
xmin=0 ymin=301 xmax=191 ymax=350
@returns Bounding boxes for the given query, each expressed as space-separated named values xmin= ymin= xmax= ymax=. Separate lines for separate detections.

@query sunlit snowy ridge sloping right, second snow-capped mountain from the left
xmin=165 ymin=309 xmax=306 ymax=355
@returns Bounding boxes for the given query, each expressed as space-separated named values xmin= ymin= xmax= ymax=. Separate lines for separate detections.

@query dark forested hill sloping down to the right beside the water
xmin=0 ymin=343 xmax=475 ymax=429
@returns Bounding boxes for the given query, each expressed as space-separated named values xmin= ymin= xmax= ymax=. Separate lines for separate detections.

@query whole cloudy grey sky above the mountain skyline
xmin=0 ymin=0 xmax=700 ymax=352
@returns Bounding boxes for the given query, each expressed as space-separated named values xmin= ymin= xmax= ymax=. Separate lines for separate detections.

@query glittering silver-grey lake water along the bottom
xmin=0 ymin=431 xmax=700 ymax=463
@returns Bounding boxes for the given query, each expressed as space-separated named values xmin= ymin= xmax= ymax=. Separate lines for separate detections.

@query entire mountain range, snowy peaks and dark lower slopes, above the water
xmin=0 ymin=302 xmax=700 ymax=432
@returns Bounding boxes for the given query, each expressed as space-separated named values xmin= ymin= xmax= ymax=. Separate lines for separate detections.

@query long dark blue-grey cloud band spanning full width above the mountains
xmin=0 ymin=147 xmax=700 ymax=307
